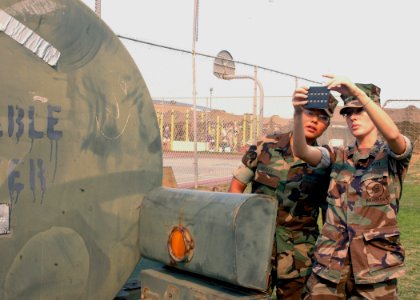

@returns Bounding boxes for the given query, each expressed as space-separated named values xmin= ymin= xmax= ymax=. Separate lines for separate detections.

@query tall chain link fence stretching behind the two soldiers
xmin=114 ymin=36 xmax=420 ymax=187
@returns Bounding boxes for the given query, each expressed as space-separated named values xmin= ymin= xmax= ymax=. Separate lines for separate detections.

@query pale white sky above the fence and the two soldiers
xmin=79 ymin=0 xmax=420 ymax=118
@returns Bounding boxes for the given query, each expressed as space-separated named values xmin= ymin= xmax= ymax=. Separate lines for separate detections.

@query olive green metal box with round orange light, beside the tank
xmin=139 ymin=188 xmax=277 ymax=290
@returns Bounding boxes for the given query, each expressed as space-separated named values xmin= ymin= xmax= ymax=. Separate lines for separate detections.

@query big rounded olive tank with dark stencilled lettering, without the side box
xmin=0 ymin=0 xmax=162 ymax=299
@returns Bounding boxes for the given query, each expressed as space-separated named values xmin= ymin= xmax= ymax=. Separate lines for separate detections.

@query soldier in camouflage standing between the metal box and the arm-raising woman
xmin=229 ymin=97 xmax=337 ymax=299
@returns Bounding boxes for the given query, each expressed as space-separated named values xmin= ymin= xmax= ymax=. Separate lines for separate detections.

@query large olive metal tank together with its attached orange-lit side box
xmin=0 ymin=0 xmax=277 ymax=300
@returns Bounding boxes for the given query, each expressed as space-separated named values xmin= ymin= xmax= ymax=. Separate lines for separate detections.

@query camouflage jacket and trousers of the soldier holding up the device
xmin=307 ymin=137 xmax=412 ymax=299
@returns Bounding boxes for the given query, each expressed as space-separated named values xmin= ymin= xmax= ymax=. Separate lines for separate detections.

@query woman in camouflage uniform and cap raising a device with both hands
xmin=293 ymin=75 xmax=412 ymax=300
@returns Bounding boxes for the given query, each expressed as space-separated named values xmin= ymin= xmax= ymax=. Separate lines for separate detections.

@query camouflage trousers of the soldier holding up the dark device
xmin=302 ymin=255 xmax=398 ymax=300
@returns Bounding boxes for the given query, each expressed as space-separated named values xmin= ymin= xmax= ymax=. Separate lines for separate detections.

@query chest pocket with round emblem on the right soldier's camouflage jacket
xmin=360 ymin=169 xmax=391 ymax=205
